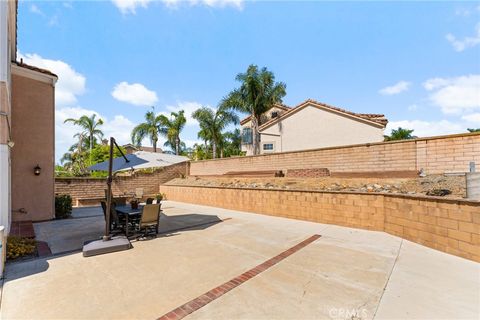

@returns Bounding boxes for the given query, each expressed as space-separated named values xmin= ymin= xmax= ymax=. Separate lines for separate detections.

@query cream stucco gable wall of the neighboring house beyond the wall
xmin=260 ymin=106 xmax=383 ymax=153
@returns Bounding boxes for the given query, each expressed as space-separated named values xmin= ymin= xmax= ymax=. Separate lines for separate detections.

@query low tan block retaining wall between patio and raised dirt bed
xmin=160 ymin=185 xmax=480 ymax=262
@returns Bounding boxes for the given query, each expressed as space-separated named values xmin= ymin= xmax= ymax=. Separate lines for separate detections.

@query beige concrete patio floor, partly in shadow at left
xmin=0 ymin=201 xmax=480 ymax=319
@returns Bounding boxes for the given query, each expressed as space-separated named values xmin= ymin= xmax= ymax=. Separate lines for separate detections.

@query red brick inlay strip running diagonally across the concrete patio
xmin=158 ymin=234 xmax=321 ymax=320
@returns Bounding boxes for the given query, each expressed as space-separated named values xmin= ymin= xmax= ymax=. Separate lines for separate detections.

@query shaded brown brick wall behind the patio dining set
xmin=55 ymin=162 xmax=188 ymax=206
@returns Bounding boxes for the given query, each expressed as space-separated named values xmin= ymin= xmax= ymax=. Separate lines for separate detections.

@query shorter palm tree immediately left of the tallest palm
xmin=192 ymin=107 xmax=238 ymax=159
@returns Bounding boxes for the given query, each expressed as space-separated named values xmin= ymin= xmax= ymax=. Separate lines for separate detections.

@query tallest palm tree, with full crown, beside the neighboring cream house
xmin=221 ymin=65 xmax=286 ymax=154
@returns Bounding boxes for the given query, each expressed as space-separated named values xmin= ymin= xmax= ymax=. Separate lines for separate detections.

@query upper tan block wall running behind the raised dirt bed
xmin=190 ymin=133 xmax=480 ymax=176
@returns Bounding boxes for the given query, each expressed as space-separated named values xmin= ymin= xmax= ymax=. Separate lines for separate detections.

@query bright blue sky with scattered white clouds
xmin=18 ymin=0 xmax=480 ymax=159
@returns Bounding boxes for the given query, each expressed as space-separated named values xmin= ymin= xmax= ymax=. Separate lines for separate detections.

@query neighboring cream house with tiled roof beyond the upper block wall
xmin=240 ymin=99 xmax=388 ymax=155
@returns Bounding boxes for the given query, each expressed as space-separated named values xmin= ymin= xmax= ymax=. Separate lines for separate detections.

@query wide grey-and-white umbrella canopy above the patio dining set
xmin=88 ymin=151 xmax=189 ymax=172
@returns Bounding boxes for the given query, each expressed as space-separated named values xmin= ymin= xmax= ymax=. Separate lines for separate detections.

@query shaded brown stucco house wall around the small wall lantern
xmin=12 ymin=70 xmax=55 ymax=221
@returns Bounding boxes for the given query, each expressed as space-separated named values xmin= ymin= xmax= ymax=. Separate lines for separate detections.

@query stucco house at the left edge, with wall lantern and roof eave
xmin=0 ymin=0 xmax=57 ymax=232
